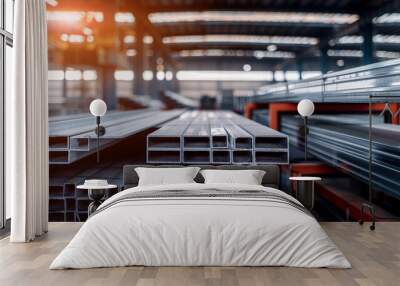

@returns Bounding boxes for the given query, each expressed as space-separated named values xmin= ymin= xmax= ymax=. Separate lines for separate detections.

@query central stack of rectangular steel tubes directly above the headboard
xmin=147 ymin=111 xmax=289 ymax=164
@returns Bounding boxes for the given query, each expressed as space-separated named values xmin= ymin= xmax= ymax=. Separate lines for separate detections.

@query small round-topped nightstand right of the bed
xmin=289 ymin=177 xmax=321 ymax=210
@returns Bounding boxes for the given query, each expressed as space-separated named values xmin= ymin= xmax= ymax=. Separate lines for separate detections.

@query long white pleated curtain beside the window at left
xmin=6 ymin=0 xmax=49 ymax=242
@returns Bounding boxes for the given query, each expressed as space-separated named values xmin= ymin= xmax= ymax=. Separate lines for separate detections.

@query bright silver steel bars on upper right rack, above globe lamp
xmin=253 ymin=59 xmax=400 ymax=103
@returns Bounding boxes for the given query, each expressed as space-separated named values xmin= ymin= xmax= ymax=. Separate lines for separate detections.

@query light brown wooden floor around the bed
xmin=0 ymin=222 xmax=400 ymax=286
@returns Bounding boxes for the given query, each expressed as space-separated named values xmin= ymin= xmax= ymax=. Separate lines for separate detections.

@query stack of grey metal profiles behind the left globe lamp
xmin=49 ymin=109 xmax=184 ymax=164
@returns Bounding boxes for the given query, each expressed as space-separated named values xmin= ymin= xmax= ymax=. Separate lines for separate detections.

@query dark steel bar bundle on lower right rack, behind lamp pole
xmin=281 ymin=116 xmax=400 ymax=198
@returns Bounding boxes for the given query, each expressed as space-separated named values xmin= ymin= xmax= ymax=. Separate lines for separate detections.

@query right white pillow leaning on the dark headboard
xmin=200 ymin=170 xmax=265 ymax=185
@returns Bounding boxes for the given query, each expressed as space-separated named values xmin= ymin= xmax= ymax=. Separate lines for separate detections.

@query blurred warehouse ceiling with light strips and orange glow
xmin=47 ymin=0 xmax=400 ymax=70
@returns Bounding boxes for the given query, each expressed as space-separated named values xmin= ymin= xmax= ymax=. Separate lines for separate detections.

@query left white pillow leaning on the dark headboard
xmin=135 ymin=167 xmax=200 ymax=186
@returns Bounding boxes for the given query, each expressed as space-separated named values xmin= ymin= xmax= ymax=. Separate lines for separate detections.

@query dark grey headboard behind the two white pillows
xmin=123 ymin=165 xmax=280 ymax=189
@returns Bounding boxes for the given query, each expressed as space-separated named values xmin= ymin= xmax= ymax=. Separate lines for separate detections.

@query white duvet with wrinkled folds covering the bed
xmin=50 ymin=183 xmax=351 ymax=269
